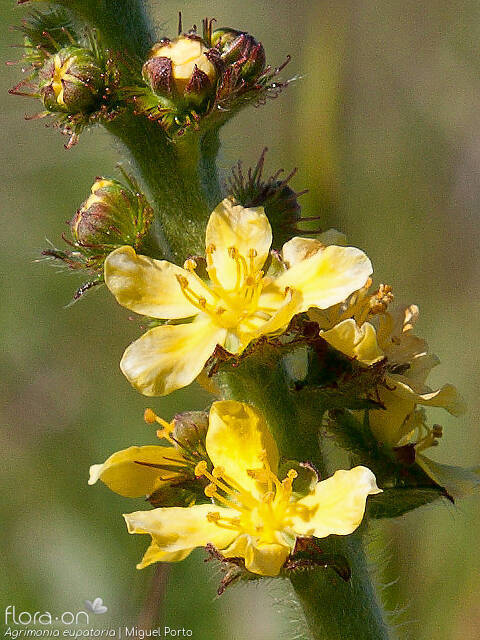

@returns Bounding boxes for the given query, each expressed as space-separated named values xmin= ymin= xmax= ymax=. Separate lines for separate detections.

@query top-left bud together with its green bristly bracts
xmin=10 ymin=9 xmax=121 ymax=148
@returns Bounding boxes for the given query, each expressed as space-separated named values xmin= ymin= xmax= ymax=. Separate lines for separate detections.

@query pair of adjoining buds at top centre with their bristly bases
xmin=131 ymin=19 xmax=288 ymax=135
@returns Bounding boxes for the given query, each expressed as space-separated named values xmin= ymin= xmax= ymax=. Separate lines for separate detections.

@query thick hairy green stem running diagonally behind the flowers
xmin=62 ymin=0 xmax=388 ymax=640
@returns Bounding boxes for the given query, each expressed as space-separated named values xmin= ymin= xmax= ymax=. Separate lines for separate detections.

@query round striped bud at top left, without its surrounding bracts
xmin=38 ymin=46 xmax=103 ymax=114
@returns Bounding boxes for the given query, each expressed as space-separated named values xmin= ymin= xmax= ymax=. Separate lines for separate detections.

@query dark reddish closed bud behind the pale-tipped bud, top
xmin=212 ymin=27 xmax=266 ymax=81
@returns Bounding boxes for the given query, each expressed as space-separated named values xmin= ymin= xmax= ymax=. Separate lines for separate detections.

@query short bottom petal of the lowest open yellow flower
xmin=223 ymin=534 xmax=291 ymax=577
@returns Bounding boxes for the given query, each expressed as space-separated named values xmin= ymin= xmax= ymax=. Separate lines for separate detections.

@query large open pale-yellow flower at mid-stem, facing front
xmin=105 ymin=199 xmax=372 ymax=396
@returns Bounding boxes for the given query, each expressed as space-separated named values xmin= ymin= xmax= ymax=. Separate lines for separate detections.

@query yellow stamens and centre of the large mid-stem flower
xmin=176 ymin=245 xmax=292 ymax=331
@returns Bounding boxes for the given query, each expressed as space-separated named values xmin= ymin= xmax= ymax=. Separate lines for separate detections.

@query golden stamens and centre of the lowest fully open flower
xmin=195 ymin=455 xmax=298 ymax=543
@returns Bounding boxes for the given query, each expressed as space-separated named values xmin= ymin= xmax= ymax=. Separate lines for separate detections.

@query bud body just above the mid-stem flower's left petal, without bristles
xmin=70 ymin=178 xmax=152 ymax=253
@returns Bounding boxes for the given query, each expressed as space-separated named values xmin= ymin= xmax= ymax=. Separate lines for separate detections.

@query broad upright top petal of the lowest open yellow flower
xmin=206 ymin=400 xmax=278 ymax=494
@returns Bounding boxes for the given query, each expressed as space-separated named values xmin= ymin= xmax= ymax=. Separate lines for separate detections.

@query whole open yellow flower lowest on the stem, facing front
xmin=124 ymin=401 xmax=380 ymax=576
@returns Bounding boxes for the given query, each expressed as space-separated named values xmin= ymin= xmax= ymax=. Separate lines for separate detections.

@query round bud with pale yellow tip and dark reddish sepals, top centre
xmin=143 ymin=35 xmax=217 ymax=104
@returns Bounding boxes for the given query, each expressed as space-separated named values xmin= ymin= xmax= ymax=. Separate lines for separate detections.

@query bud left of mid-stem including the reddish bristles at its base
xmin=43 ymin=174 xmax=153 ymax=298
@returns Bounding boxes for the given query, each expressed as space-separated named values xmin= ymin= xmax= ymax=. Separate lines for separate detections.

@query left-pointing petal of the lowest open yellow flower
xmin=123 ymin=504 xmax=238 ymax=553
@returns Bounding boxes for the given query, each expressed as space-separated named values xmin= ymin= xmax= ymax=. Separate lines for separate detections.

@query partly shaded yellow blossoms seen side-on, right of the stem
xmin=320 ymin=306 xmax=480 ymax=499
